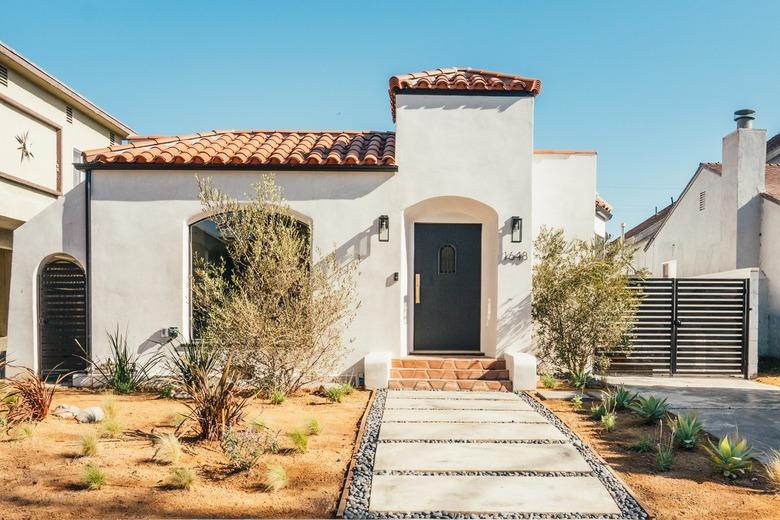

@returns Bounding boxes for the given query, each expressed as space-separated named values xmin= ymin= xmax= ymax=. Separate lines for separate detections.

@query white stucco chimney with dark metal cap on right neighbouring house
xmin=719 ymin=109 xmax=766 ymax=271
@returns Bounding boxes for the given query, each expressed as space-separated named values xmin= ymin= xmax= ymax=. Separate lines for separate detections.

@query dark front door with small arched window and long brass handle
xmin=412 ymin=224 xmax=482 ymax=351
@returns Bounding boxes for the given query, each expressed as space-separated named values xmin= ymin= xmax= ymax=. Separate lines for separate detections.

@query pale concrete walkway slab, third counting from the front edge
xmin=379 ymin=416 xmax=566 ymax=441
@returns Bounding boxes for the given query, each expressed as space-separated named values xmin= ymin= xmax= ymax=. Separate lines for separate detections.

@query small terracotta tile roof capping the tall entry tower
xmin=389 ymin=67 xmax=542 ymax=121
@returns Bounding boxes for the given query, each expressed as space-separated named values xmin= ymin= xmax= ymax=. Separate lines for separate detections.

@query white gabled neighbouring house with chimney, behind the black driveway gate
xmin=626 ymin=111 xmax=780 ymax=357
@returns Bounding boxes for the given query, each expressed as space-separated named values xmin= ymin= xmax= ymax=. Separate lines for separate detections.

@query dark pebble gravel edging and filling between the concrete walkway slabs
xmin=344 ymin=390 xmax=649 ymax=520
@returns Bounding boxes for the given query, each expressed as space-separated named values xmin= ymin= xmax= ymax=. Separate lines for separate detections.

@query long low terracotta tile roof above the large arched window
xmin=83 ymin=130 xmax=395 ymax=168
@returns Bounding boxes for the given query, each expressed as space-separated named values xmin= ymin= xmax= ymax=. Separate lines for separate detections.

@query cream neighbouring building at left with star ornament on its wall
xmin=0 ymin=42 xmax=131 ymax=353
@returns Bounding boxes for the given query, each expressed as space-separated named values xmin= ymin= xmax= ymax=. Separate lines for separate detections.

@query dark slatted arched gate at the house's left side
xmin=38 ymin=257 xmax=87 ymax=376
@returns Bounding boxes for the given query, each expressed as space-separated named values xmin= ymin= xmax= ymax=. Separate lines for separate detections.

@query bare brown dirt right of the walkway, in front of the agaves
xmin=540 ymin=394 xmax=780 ymax=520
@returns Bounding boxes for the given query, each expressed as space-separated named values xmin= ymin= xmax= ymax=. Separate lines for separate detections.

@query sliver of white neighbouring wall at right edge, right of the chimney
xmin=760 ymin=198 xmax=780 ymax=357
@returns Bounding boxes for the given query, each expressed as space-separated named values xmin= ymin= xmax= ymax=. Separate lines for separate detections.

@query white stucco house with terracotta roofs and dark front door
xmin=8 ymin=68 xmax=611 ymax=388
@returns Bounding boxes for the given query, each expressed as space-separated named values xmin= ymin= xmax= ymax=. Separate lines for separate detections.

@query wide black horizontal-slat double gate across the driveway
xmin=610 ymin=278 xmax=749 ymax=375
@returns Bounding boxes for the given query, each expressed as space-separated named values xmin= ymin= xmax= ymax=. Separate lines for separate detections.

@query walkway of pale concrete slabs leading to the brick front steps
xmin=369 ymin=391 xmax=621 ymax=515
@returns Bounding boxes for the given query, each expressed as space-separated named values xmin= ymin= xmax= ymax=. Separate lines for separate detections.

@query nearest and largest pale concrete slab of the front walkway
xmin=369 ymin=475 xmax=620 ymax=515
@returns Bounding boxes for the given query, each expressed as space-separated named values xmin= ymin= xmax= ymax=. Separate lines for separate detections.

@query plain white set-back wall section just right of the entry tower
xmin=533 ymin=153 xmax=604 ymax=240
